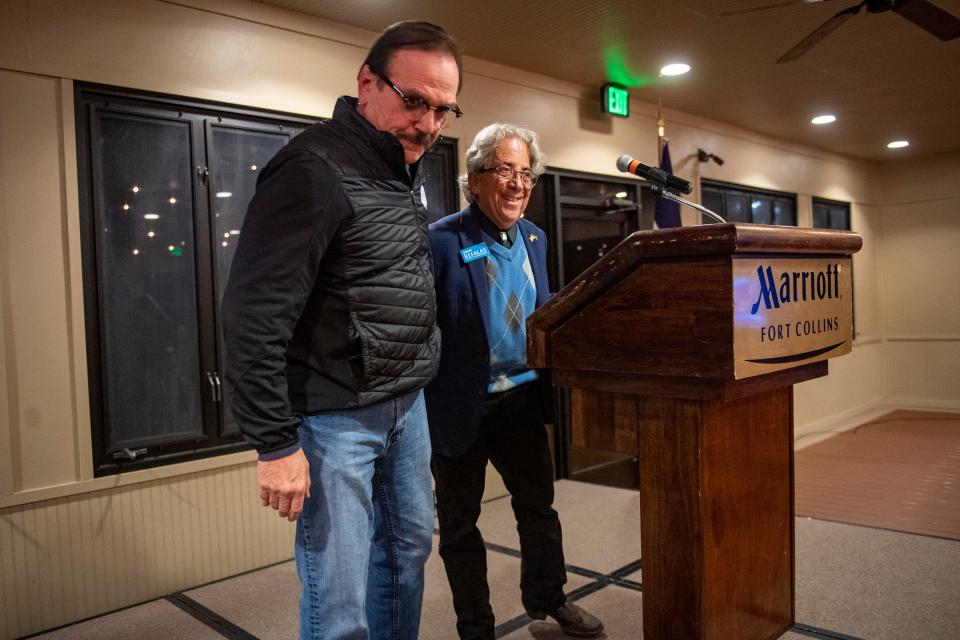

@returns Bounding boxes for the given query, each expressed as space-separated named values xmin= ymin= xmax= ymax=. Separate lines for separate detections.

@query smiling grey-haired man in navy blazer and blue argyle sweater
xmin=426 ymin=123 xmax=603 ymax=640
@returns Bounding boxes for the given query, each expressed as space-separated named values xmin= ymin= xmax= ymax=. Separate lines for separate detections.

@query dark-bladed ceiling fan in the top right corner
xmin=719 ymin=0 xmax=960 ymax=63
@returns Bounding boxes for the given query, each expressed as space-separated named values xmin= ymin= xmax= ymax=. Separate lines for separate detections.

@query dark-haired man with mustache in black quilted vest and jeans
xmin=222 ymin=22 xmax=462 ymax=640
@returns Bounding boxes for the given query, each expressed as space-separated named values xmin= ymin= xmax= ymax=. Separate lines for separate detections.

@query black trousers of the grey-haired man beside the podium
xmin=432 ymin=383 xmax=567 ymax=640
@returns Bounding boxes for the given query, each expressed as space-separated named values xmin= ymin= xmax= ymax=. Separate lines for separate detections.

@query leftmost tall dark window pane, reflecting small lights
xmin=93 ymin=112 xmax=203 ymax=450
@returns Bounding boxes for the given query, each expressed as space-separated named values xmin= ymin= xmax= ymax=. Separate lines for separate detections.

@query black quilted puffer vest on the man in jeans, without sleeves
xmin=287 ymin=98 xmax=440 ymax=413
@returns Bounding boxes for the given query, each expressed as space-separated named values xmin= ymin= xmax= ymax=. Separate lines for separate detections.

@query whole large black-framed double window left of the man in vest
xmin=76 ymin=83 xmax=318 ymax=475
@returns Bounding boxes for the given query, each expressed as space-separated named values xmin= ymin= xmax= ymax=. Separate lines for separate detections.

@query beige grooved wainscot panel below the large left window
xmin=0 ymin=465 xmax=298 ymax=638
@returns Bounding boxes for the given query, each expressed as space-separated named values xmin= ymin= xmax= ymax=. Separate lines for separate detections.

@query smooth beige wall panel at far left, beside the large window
xmin=0 ymin=71 xmax=76 ymax=490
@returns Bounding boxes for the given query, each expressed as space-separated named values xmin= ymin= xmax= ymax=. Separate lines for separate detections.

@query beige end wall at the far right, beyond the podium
xmin=878 ymin=155 xmax=960 ymax=410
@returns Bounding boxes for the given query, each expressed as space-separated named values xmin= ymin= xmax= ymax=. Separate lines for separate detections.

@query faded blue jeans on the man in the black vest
xmin=295 ymin=391 xmax=433 ymax=640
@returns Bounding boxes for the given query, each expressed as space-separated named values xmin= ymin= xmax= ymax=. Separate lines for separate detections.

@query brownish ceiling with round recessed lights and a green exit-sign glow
xmin=258 ymin=0 xmax=960 ymax=161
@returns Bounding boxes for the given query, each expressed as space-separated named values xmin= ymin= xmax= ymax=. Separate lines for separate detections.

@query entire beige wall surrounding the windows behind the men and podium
xmin=0 ymin=0 xmax=960 ymax=637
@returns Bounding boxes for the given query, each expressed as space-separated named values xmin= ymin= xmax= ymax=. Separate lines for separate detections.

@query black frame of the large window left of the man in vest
xmin=74 ymin=82 xmax=317 ymax=477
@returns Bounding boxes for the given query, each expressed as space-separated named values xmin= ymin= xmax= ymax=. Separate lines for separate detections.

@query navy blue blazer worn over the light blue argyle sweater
xmin=426 ymin=204 xmax=552 ymax=456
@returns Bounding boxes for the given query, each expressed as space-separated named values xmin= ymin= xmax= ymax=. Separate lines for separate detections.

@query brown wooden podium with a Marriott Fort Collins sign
xmin=527 ymin=224 xmax=861 ymax=640
